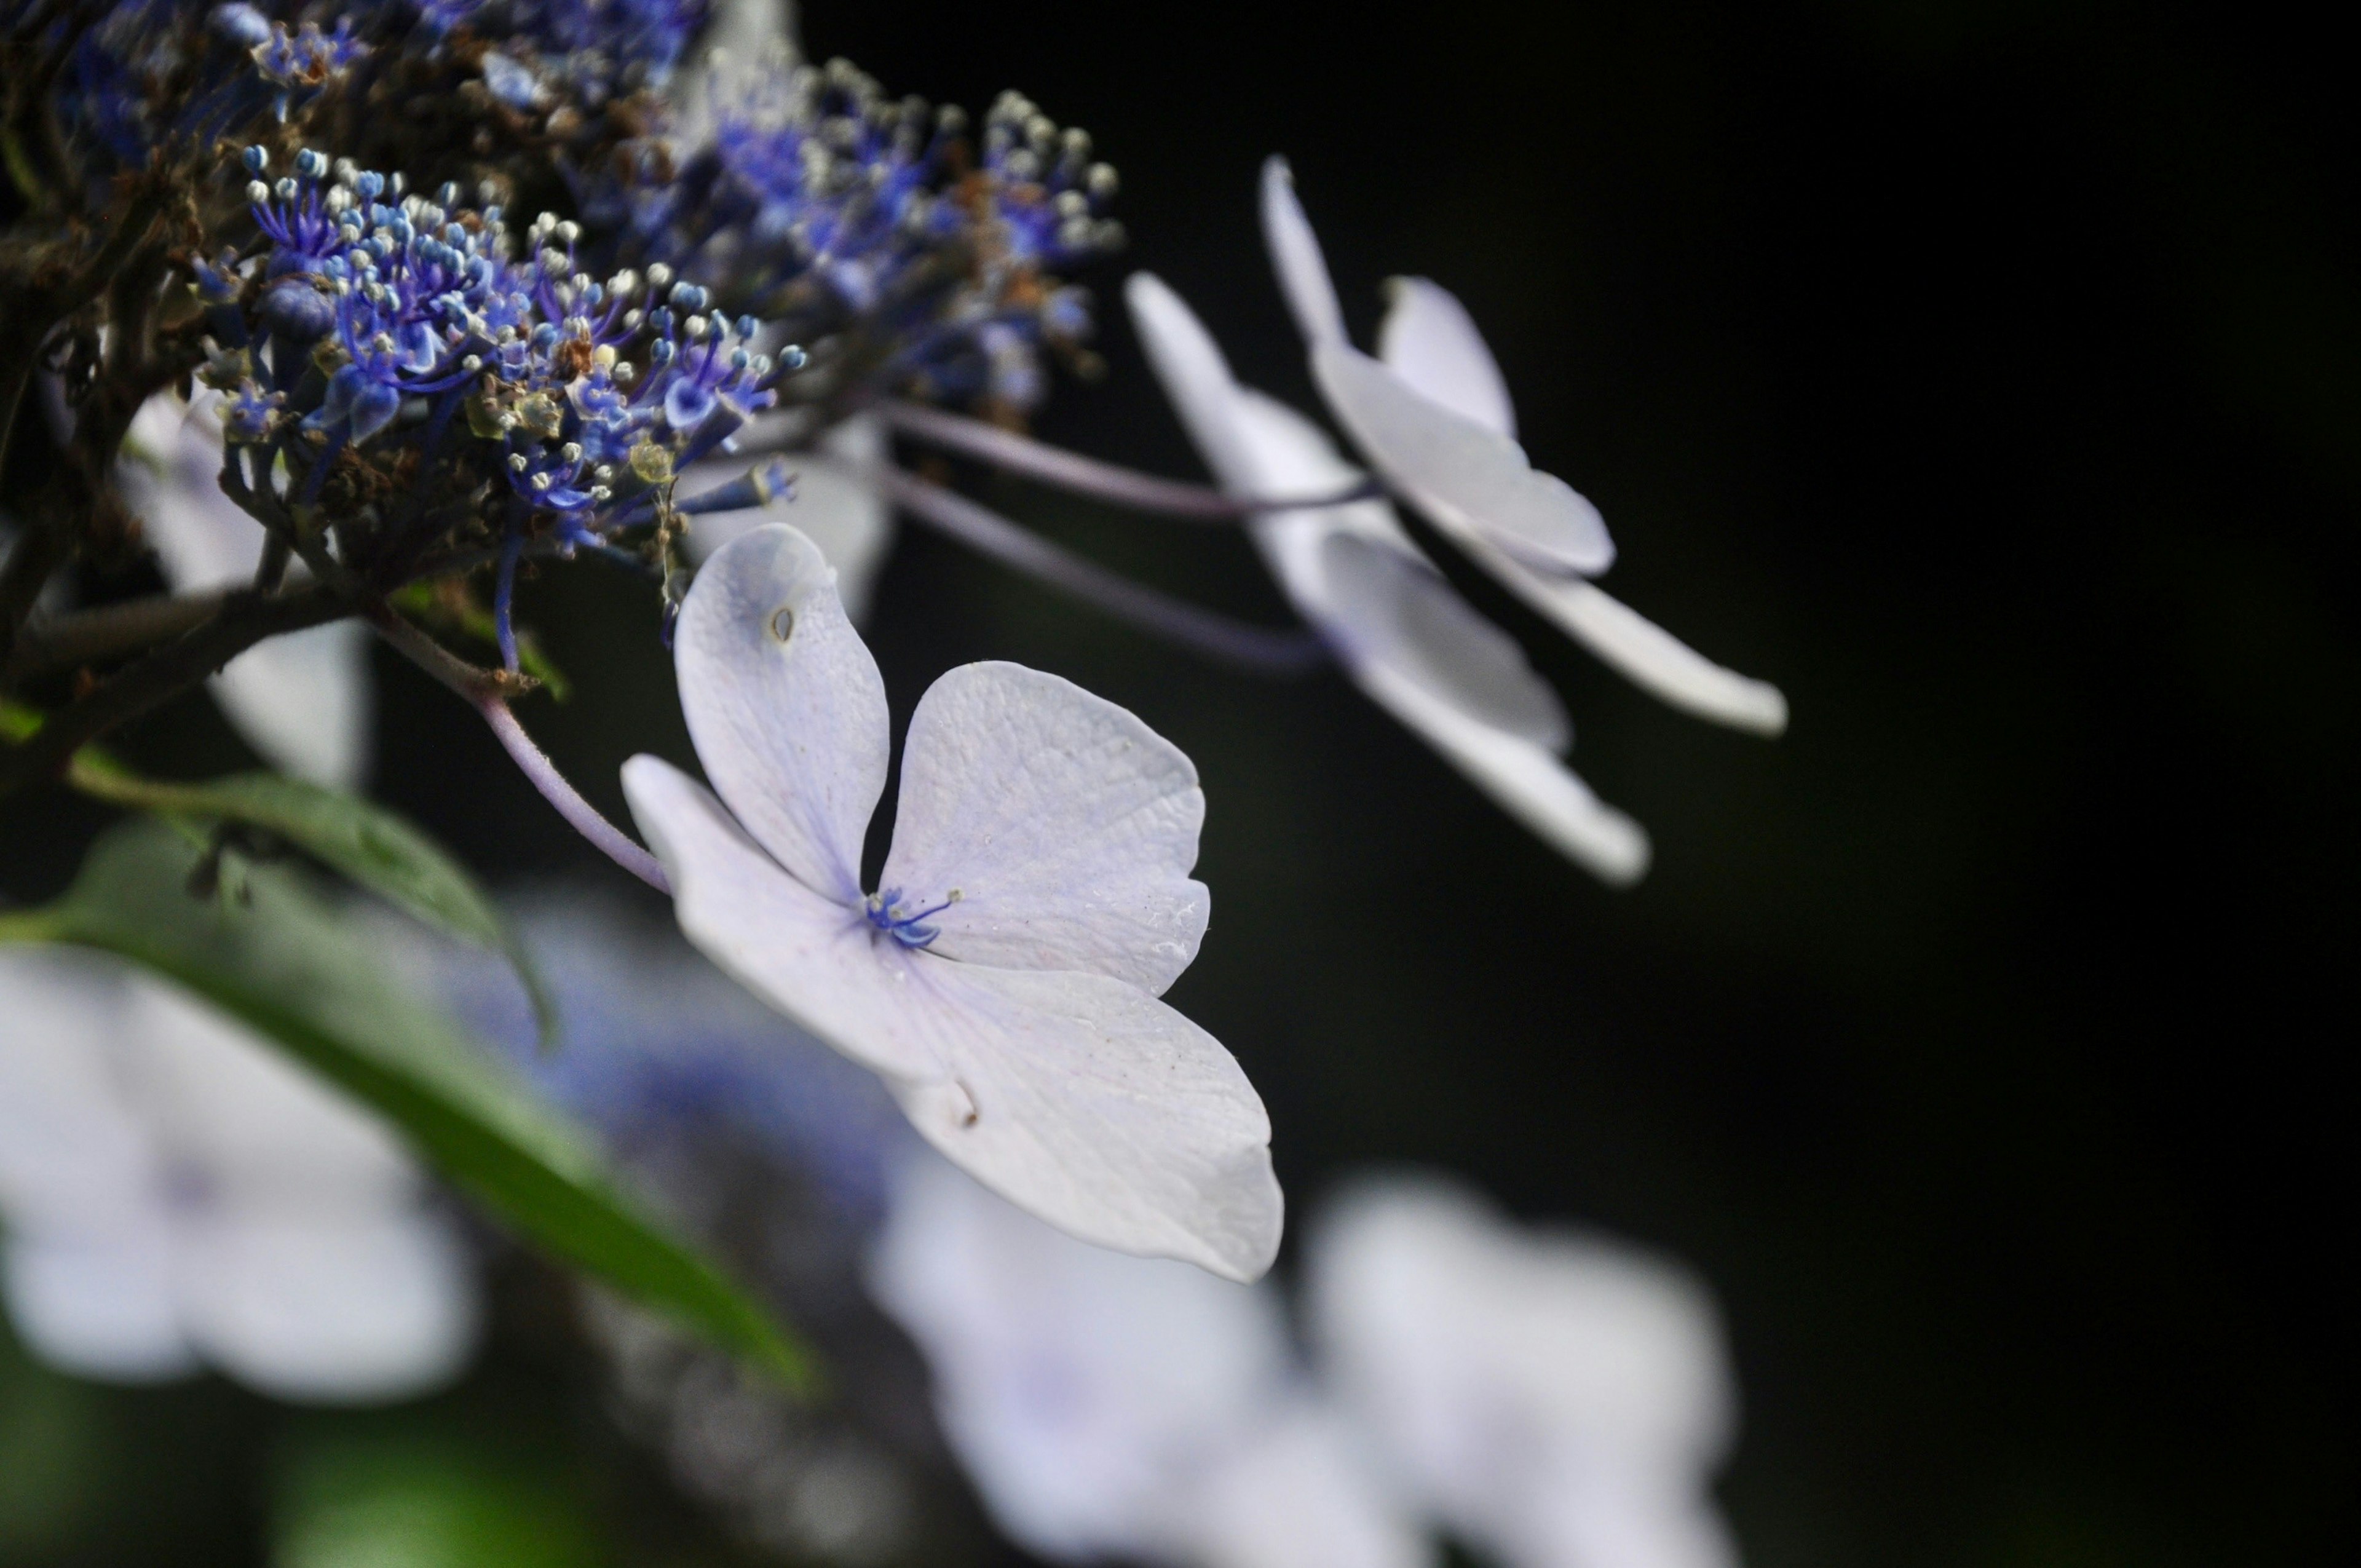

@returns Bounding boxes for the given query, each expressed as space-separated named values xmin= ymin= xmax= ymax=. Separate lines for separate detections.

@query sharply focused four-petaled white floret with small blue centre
xmin=623 ymin=525 xmax=1282 ymax=1280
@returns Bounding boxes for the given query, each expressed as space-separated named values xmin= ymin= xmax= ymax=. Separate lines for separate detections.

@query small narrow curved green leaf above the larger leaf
xmin=66 ymin=748 xmax=557 ymax=1046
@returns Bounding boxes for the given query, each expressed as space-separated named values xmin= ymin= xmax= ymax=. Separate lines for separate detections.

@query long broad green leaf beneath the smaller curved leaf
xmin=0 ymin=820 xmax=815 ymax=1388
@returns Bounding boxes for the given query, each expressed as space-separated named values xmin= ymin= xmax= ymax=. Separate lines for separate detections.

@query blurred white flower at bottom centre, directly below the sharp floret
xmin=869 ymin=1157 xmax=1431 ymax=1568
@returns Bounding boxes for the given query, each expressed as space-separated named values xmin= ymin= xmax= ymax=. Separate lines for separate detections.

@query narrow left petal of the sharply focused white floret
xmin=623 ymin=756 xmax=942 ymax=1079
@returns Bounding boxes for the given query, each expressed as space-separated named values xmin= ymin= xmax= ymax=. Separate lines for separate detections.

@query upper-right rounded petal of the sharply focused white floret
xmin=880 ymin=663 xmax=1211 ymax=992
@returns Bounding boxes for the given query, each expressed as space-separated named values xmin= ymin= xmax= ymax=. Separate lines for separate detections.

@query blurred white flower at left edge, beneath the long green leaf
xmin=0 ymin=949 xmax=477 ymax=1403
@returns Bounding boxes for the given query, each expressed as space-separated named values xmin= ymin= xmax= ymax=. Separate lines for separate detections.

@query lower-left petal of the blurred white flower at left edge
xmin=0 ymin=1216 xmax=196 ymax=1384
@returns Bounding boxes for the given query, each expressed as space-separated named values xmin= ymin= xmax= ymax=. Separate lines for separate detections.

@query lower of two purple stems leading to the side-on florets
xmin=869 ymin=467 xmax=1327 ymax=675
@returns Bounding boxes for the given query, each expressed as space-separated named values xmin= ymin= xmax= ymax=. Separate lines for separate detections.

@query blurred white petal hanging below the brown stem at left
xmin=213 ymin=621 xmax=378 ymax=789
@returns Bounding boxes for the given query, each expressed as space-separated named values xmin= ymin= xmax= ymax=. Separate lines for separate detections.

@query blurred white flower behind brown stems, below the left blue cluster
xmin=116 ymin=392 xmax=376 ymax=789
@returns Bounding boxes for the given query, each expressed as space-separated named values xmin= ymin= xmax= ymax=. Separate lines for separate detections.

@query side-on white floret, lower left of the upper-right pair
xmin=1124 ymin=274 xmax=1648 ymax=883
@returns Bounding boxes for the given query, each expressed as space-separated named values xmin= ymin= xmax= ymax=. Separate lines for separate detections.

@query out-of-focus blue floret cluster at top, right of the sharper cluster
xmin=609 ymin=61 xmax=1121 ymax=411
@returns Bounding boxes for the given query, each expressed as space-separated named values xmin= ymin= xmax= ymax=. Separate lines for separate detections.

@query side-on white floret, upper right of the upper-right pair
xmin=1263 ymin=158 xmax=1787 ymax=734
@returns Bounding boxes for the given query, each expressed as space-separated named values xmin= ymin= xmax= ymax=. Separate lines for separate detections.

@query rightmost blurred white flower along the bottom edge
xmin=1308 ymin=1178 xmax=1738 ymax=1568
